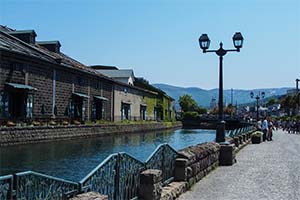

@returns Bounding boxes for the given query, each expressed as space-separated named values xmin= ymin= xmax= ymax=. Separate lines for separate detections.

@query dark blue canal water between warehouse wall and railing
xmin=0 ymin=129 xmax=215 ymax=181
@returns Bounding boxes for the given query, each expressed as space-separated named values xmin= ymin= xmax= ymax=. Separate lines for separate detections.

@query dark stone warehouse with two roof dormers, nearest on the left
xmin=0 ymin=27 xmax=114 ymax=121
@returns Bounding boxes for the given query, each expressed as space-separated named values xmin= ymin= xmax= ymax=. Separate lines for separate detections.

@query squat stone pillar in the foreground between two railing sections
xmin=139 ymin=169 xmax=162 ymax=200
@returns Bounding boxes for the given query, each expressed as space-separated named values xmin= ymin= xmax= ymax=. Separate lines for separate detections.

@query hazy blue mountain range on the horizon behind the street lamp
xmin=153 ymin=84 xmax=291 ymax=108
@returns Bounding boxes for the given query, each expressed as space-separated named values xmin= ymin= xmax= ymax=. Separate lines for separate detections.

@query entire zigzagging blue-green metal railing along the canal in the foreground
xmin=0 ymin=144 xmax=177 ymax=200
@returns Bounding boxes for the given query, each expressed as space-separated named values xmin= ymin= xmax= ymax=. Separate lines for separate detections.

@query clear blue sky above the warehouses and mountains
xmin=0 ymin=0 xmax=300 ymax=89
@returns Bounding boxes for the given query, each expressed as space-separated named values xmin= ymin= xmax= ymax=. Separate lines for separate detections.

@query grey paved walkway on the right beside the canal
xmin=179 ymin=131 xmax=300 ymax=200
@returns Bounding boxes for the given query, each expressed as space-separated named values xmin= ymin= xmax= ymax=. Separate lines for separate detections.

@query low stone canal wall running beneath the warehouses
xmin=0 ymin=122 xmax=182 ymax=146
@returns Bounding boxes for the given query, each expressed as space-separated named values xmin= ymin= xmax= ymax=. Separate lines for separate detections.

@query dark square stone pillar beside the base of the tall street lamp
xmin=219 ymin=144 xmax=235 ymax=166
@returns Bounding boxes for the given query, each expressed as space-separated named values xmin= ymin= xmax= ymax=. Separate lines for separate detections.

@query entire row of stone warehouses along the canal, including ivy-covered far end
xmin=0 ymin=26 xmax=174 ymax=124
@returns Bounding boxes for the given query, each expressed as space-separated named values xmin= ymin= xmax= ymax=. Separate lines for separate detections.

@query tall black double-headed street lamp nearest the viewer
xmin=199 ymin=32 xmax=244 ymax=142
